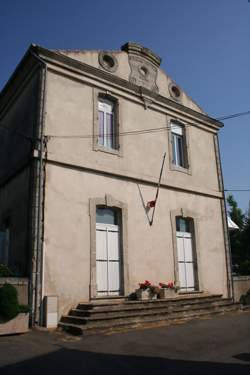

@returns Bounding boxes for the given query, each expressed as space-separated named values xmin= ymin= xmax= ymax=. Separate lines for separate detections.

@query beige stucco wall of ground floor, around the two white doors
xmin=44 ymin=164 xmax=227 ymax=315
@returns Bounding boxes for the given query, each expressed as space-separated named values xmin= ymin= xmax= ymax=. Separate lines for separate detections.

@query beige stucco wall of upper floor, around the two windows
xmin=45 ymin=72 xmax=221 ymax=197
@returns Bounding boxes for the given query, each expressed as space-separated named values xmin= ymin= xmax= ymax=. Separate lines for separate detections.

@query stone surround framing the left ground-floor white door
xmin=89 ymin=194 xmax=129 ymax=299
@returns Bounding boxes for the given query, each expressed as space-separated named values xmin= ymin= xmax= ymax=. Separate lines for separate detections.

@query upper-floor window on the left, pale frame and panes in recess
xmin=98 ymin=98 xmax=117 ymax=150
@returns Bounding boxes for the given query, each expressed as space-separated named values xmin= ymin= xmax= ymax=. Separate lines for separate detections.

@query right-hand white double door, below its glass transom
xmin=176 ymin=232 xmax=195 ymax=292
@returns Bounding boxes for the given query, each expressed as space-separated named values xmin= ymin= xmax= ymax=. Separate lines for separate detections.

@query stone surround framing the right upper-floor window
xmin=167 ymin=116 xmax=192 ymax=175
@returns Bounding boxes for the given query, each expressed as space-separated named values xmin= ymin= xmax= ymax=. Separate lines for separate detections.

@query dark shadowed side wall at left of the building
xmin=0 ymin=60 xmax=40 ymax=276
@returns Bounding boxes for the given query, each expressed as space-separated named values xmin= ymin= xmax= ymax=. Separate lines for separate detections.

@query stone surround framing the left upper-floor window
xmin=93 ymin=88 xmax=122 ymax=157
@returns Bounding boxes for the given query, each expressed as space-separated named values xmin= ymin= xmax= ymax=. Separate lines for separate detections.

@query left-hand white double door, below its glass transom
xmin=96 ymin=223 xmax=121 ymax=296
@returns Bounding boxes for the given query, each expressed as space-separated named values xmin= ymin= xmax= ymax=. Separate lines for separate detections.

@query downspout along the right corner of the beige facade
xmin=214 ymin=134 xmax=234 ymax=300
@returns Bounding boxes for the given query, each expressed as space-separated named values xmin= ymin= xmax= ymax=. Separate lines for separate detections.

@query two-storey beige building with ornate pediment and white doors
xmin=0 ymin=43 xmax=232 ymax=322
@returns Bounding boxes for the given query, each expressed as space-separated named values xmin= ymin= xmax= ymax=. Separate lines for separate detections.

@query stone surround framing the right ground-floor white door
xmin=170 ymin=208 xmax=203 ymax=293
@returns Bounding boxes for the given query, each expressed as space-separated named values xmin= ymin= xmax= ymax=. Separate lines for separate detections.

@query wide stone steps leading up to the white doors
xmin=59 ymin=293 xmax=240 ymax=335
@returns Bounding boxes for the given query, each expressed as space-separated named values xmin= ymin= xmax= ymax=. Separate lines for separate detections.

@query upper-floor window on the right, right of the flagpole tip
xmin=171 ymin=123 xmax=187 ymax=168
